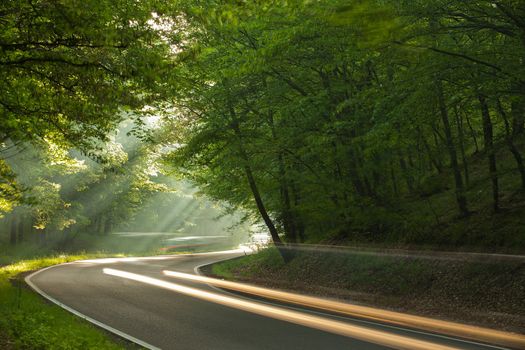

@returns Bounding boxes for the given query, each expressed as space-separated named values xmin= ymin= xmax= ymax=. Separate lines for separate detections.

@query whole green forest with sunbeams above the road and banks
xmin=0 ymin=0 xmax=525 ymax=258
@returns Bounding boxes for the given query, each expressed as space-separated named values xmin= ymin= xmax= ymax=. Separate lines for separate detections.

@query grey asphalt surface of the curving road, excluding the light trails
xmin=28 ymin=252 xmax=510 ymax=350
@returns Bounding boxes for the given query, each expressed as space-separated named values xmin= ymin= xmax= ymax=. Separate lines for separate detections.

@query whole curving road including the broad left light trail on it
xmin=26 ymin=251 xmax=516 ymax=350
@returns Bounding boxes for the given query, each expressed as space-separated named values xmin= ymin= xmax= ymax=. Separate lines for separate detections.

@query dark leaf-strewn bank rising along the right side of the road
xmin=211 ymin=248 xmax=525 ymax=333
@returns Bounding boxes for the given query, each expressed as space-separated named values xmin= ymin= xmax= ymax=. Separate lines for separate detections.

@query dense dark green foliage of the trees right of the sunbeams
xmin=161 ymin=0 xmax=525 ymax=249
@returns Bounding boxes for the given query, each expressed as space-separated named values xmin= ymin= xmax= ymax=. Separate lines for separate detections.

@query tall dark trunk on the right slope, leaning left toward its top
xmin=436 ymin=79 xmax=469 ymax=216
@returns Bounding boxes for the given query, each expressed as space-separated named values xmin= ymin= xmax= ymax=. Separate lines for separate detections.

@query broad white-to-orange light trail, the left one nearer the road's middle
xmin=103 ymin=268 xmax=456 ymax=350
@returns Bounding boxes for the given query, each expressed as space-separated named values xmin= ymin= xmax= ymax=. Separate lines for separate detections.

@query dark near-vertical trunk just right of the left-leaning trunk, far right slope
xmin=478 ymin=93 xmax=499 ymax=212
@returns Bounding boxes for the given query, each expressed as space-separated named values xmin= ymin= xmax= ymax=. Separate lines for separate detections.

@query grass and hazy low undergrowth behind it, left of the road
xmin=0 ymin=234 xmax=223 ymax=350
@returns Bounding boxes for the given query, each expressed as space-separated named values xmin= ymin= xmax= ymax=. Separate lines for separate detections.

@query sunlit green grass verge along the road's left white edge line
xmin=0 ymin=254 xmax=137 ymax=349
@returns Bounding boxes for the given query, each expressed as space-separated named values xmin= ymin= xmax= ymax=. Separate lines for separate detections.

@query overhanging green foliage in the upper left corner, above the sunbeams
xmin=0 ymin=0 xmax=176 ymax=217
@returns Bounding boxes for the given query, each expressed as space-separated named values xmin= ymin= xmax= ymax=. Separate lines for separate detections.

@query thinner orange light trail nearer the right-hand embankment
xmin=163 ymin=270 xmax=525 ymax=349
